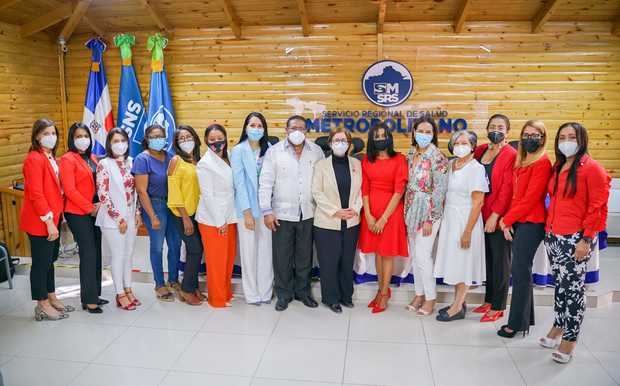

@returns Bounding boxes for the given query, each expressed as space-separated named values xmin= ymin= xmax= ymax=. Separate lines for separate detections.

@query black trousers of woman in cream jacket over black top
xmin=314 ymin=225 xmax=359 ymax=304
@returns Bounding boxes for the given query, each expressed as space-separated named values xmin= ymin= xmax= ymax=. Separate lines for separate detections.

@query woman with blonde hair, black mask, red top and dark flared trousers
xmin=497 ymin=121 xmax=551 ymax=338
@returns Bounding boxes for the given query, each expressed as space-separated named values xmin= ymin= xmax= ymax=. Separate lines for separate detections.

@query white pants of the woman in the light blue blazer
xmin=237 ymin=217 xmax=273 ymax=303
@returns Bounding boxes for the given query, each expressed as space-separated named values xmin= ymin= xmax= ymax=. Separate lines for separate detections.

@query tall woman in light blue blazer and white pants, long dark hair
xmin=230 ymin=112 xmax=273 ymax=306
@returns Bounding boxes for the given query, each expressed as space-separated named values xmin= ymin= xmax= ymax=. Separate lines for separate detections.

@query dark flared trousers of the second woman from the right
xmin=508 ymin=223 xmax=545 ymax=331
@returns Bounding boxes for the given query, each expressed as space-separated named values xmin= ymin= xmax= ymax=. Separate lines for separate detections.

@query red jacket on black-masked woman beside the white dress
xmin=474 ymin=144 xmax=517 ymax=227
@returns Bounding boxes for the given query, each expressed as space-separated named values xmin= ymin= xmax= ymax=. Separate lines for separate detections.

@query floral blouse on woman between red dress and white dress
xmin=405 ymin=144 xmax=448 ymax=233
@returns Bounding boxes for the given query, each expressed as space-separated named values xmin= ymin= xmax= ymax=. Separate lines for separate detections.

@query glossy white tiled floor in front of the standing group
xmin=0 ymin=259 xmax=620 ymax=386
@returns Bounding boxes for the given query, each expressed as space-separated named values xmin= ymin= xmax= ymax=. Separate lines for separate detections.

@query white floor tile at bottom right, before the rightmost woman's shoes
xmin=508 ymin=347 xmax=616 ymax=386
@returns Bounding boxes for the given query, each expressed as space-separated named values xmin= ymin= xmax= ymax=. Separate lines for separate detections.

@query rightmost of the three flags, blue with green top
xmin=146 ymin=33 xmax=176 ymax=154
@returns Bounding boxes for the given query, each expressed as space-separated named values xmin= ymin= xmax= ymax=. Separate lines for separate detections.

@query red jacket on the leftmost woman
xmin=19 ymin=150 xmax=63 ymax=236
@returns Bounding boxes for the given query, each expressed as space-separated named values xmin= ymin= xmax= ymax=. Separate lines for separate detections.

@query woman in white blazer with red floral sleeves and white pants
xmin=95 ymin=128 xmax=141 ymax=311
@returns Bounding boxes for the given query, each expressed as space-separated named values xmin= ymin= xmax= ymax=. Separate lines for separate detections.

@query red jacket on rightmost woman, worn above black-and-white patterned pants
xmin=546 ymin=155 xmax=611 ymax=237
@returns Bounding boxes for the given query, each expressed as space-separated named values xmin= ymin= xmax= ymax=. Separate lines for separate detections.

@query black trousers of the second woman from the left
xmin=65 ymin=213 xmax=101 ymax=304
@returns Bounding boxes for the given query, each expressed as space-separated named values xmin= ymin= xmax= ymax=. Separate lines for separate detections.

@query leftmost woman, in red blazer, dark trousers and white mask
xmin=19 ymin=119 xmax=74 ymax=321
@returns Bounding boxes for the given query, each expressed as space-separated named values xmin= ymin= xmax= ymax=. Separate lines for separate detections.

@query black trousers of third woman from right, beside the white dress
xmin=484 ymin=230 xmax=510 ymax=311
